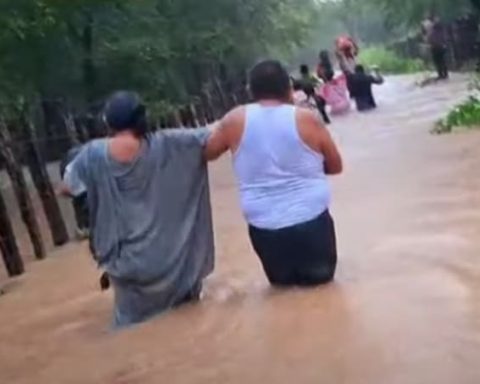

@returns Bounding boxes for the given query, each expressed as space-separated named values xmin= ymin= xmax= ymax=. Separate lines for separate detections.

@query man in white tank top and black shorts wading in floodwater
xmin=206 ymin=60 xmax=342 ymax=286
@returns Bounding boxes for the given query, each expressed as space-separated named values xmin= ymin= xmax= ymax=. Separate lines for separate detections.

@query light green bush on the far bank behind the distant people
xmin=359 ymin=47 xmax=425 ymax=74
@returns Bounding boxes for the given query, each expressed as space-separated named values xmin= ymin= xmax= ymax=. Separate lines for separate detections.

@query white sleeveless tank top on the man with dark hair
xmin=233 ymin=104 xmax=330 ymax=229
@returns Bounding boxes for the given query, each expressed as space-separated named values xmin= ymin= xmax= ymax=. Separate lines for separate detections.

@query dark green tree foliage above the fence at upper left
xmin=0 ymin=0 xmax=315 ymax=114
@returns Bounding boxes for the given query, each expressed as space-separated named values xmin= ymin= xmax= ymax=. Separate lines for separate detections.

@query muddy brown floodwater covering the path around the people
xmin=0 ymin=76 xmax=480 ymax=384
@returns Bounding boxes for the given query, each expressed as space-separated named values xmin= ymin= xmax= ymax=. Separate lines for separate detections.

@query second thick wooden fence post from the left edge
xmin=0 ymin=119 xmax=46 ymax=260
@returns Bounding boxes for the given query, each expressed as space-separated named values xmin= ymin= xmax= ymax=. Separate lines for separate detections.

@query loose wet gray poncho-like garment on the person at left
xmin=65 ymin=129 xmax=214 ymax=326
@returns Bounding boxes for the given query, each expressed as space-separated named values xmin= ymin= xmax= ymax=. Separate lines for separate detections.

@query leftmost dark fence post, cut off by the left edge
xmin=0 ymin=186 xmax=25 ymax=277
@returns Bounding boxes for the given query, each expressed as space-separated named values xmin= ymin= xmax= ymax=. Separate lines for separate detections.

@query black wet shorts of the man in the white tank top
xmin=249 ymin=211 xmax=337 ymax=286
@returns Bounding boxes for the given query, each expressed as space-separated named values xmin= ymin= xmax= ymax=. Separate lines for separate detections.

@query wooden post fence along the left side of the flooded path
xmin=0 ymin=82 xmax=248 ymax=276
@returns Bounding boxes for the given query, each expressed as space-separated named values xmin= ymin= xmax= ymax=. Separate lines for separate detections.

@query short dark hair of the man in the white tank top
xmin=249 ymin=60 xmax=291 ymax=101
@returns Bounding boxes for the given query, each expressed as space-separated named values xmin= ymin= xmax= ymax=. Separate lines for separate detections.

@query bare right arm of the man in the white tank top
xmin=297 ymin=110 xmax=343 ymax=175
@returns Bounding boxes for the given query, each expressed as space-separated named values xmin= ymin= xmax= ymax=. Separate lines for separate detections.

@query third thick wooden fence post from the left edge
xmin=22 ymin=116 xmax=69 ymax=246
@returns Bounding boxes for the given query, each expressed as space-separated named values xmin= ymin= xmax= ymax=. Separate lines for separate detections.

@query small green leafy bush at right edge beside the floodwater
xmin=433 ymin=96 xmax=480 ymax=134
